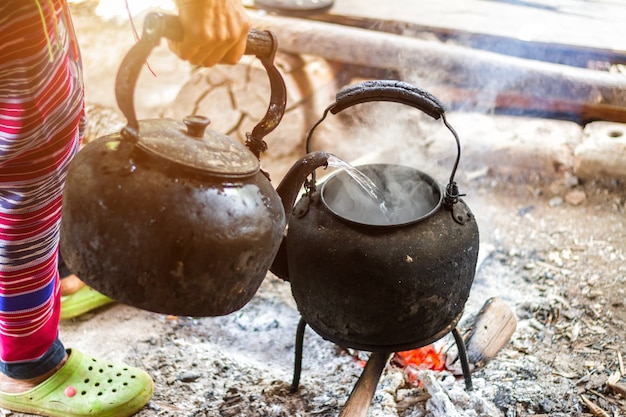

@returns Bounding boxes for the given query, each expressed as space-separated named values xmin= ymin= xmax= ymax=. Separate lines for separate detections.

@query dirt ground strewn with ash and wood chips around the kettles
xmin=4 ymin=3 xmax=626 ymax=417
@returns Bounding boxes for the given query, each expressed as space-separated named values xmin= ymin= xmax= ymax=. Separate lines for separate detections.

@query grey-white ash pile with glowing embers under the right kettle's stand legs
xmin=123 ymin=260 xmax=600 ymax=417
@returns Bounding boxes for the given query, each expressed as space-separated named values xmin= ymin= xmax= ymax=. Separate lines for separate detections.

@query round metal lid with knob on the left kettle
xmin=136 ymin=115 xmax=260 ymax=177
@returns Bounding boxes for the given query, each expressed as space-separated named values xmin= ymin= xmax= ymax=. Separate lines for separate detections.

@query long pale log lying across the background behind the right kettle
xmin=253 ymin=16 xmax=626 ymax=123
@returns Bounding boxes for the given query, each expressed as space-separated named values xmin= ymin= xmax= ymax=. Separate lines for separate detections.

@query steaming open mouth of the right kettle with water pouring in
xmin=322 ymin=157 xmax=441 ymax=226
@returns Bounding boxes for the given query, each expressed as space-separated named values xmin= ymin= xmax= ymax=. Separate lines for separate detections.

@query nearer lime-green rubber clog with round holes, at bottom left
xmin=0 ymin=349 xmax=154 ymax=417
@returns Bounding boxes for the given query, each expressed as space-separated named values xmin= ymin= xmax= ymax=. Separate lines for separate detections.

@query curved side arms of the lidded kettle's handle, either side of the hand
xmin=115 ymin=13 xmax=287 ymax=158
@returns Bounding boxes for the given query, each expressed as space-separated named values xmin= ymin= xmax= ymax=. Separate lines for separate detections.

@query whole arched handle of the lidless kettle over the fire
xmin=306 ymin=80 xmax=461 ymax=205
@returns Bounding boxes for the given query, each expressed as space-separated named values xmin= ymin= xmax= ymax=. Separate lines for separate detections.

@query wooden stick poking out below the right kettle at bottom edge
xmin=339 ymin=352 xmax=391 ymax=417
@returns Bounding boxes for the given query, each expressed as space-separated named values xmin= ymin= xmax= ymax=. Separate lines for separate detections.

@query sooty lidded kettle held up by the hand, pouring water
xmin=61 ymin=14 xmax=326 ymax=316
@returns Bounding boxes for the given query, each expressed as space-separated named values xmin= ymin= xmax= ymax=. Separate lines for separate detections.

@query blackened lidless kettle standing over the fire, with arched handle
xmin=271 ymin=81 xmax=478 ymax=352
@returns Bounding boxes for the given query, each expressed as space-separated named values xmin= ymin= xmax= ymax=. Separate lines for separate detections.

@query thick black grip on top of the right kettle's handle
xmin=330 ymin=80 xmax=445 ymax=119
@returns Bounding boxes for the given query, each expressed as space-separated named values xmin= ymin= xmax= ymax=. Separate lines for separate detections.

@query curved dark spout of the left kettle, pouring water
xmin=270 ymin=151 xmax=330 ymax=281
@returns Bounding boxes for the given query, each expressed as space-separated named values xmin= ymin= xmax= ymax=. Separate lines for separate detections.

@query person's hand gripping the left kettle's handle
xmin=169 ymin=0 xmax=250 ymax=67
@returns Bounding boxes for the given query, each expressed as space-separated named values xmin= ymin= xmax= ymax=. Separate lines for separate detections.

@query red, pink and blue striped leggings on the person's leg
xmin=0 ymin=0 xmax=84 ymax=378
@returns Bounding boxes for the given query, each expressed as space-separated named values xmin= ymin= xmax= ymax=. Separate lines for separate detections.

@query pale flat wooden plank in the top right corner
xmin=316 ymin=0 xmax=626 ymax=50
